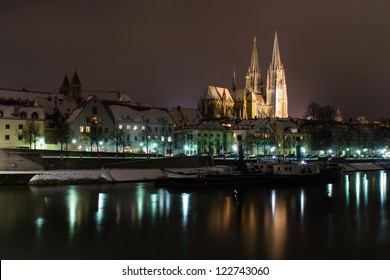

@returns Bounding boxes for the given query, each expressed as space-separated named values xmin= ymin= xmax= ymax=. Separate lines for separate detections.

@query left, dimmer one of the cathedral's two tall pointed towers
xmin=245 ymin=36 xmax=263 ymax=94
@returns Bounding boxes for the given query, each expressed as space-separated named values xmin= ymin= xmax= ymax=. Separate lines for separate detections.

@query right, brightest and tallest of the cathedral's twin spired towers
xmin=267 ymin=32 xmax=288 ymax=118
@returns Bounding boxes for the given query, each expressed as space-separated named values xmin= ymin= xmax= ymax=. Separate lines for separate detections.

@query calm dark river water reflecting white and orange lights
xmin=0 ymin=171 xmax=390 ymax=260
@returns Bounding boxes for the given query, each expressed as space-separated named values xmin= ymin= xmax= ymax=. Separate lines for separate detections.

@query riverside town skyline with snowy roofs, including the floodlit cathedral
xmin=0 ymin=33 xmax=390 ymax=158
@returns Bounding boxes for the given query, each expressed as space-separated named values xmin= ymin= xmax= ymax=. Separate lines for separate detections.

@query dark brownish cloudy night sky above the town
xmin=0 ymin=0 xmax=390 ymax=120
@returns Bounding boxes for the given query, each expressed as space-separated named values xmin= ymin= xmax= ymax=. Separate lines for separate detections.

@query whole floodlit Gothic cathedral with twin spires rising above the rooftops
xmin=198 ymin=33 xmax=288 ymax=119
